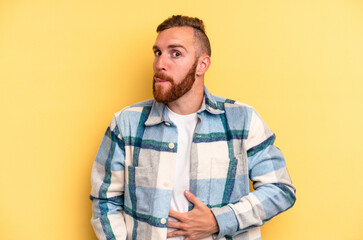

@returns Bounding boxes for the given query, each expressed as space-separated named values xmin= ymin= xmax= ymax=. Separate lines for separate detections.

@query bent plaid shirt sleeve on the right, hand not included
xmin=211 ymin=110 xmax=296 ymax=239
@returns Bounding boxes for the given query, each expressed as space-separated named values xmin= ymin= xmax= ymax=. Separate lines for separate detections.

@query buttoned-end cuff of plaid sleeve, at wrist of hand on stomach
xmin=211 ymin=206 xmax=238 ymax=239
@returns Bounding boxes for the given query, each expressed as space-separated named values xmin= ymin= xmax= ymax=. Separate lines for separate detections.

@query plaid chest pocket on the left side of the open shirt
xmin=127 ymin=166 xmax=156 ymax=218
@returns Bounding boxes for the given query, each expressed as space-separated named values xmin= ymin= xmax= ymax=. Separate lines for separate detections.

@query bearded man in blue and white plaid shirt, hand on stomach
xmin=90 ymin=16 xmax=295 ymax=240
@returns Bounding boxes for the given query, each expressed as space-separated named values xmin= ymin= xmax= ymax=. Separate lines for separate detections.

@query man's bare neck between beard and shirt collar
xmin=167 ymin=82 xmax=204 ymax=115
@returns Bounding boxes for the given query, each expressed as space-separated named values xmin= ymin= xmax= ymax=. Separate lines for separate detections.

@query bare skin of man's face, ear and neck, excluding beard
xmin=153 ymin=27 xmax=210 ymax=115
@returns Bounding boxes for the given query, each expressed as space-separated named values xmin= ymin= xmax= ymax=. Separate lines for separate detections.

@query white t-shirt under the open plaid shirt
xmin=167 ymin=108 xmax=198 ymax=240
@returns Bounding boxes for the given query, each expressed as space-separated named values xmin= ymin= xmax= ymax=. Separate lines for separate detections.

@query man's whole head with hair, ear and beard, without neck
xmin=153 ymin=15 xmax=211 ymax=103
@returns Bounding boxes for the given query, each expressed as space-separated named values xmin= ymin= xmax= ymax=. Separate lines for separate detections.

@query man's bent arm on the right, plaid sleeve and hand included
xmin=168 ymin=109 xmax=295 ymax=239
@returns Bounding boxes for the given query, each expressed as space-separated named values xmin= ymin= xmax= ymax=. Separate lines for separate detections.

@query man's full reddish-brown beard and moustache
xmin=153 ymin=60 xmax=198 ymax=104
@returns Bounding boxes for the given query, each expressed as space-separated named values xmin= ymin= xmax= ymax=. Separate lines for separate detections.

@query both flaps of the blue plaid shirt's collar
xmin=145 ymin=86 xmax=224 ymax=126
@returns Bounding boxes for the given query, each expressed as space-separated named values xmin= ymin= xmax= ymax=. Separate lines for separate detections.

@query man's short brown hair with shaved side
xmin=156 ymin=15 xmax=212 ymax=56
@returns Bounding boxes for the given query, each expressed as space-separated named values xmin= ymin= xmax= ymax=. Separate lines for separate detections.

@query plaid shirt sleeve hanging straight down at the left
xmin=90 ymin=117 xmax=126 ymax=240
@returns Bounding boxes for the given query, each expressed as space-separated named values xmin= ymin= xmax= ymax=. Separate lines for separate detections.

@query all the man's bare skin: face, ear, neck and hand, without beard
xmin=153 ymin=27 xmax=219 ymax=240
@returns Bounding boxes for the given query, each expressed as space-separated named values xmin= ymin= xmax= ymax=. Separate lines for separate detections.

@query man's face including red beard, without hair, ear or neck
xmin=153 ymin=27 xmax=198 ymax=103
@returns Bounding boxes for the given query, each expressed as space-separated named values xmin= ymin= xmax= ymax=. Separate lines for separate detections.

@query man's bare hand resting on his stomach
xmin=167 ymin=191 xmax=219 ymax=240
